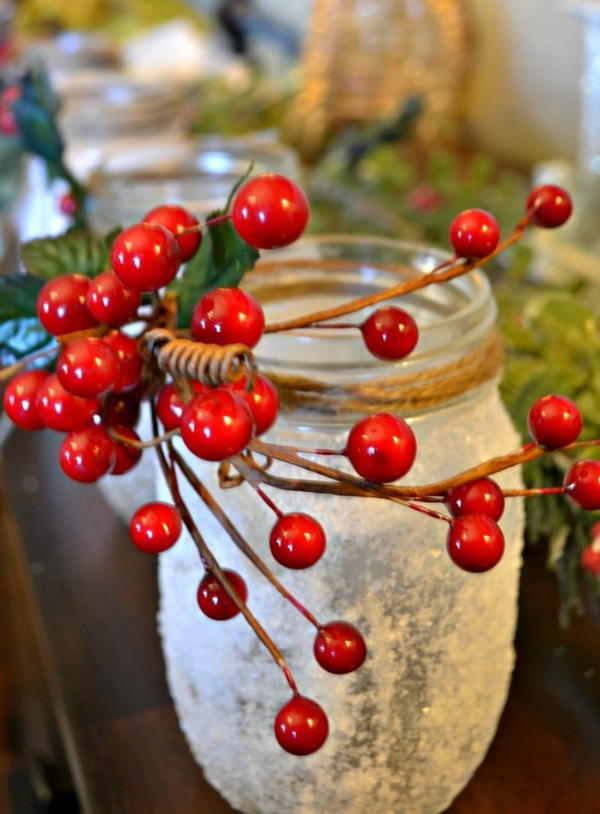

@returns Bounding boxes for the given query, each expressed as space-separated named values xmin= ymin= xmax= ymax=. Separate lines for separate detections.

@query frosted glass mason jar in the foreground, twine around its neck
xmin=159 ymin=237 xmax=523 ymax=814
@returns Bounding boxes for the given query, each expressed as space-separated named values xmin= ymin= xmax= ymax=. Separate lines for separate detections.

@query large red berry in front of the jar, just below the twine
xmin=346 ymin=413 xmax=417 ymax=483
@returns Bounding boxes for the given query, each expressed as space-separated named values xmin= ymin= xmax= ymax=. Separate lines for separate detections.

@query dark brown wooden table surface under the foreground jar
xmin=0 ymin=432 xmax=600 ymax=814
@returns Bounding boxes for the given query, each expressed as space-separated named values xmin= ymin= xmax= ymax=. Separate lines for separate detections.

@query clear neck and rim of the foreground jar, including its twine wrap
xmin=245 ymin=237 xmax=501 ymax=424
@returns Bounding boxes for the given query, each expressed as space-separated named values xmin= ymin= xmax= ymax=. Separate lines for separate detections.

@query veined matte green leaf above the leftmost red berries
xmin=21 ymin=230 xmax=110 ymax=280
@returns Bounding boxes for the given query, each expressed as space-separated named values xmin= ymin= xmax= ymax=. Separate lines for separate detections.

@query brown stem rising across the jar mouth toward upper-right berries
xmin=265 ymin=222 xmax=529 ymax=333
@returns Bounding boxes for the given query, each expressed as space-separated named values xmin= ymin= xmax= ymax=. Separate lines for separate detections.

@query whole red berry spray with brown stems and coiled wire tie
xmin=1 ymin=175 xmax=600 ymax=755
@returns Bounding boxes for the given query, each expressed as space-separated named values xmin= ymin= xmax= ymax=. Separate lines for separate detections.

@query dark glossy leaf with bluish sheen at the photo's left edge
xmin=0 ymin=274 xmax=53 ymax=366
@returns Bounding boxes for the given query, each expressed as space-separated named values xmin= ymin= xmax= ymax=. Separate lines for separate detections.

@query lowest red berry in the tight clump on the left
xmin=59 ymin=427 xmax=115 ymax=483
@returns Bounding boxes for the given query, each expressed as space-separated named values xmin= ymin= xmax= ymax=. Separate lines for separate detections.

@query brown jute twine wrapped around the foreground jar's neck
xmin=263 ymin=329 xmax=502 ymax=415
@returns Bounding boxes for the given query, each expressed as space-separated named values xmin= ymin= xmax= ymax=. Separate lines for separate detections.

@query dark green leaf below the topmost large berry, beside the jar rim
xmin=169 ymin=220 xmax=259 ymax=328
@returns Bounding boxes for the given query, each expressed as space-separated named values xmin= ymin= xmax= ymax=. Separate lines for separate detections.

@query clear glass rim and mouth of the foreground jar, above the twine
xmin=243 ymin=235 xmax=496 ymax=376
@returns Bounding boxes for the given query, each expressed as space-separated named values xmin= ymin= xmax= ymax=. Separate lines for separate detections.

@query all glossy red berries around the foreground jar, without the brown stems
xmin=0 ymin=177 xmax=584 ymax=755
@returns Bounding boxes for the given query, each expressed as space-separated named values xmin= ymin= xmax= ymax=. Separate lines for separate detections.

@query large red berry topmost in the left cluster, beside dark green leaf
xmin=231 ymin=174 xmax=308 ymax=249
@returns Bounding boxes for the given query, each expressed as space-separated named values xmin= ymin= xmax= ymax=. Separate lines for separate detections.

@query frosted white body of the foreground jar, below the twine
xmin=158 ymin=390 xmax=523 ymax=814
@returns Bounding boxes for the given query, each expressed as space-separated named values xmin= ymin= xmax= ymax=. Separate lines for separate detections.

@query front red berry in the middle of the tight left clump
xmin=56 ymin=336 xmax=118 ymax=396
